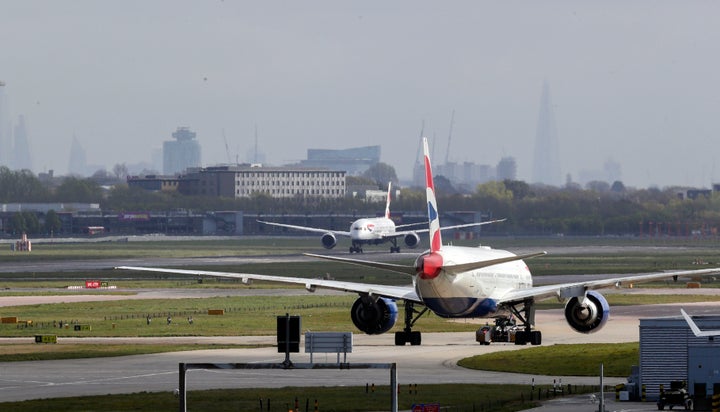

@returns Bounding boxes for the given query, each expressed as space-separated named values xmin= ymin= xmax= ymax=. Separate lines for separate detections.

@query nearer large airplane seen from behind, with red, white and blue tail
xmin=118 ymin=138 xmax=720 ymax=346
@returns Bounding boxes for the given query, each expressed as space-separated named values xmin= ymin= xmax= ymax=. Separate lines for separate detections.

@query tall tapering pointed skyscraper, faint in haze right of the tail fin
xmin=533 ymin=82 xmax=562 ymax=186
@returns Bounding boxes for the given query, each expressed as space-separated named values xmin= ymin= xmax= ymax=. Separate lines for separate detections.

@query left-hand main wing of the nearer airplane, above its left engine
xmin=115 ymin=266 xmax=421 ymax=303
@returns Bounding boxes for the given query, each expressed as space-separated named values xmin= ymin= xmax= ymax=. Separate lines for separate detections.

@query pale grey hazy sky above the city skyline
xmin=0 ymin=0 xmax=720 ymax=187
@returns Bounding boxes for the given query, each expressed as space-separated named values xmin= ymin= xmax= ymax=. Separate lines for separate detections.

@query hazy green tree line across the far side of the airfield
xmin=0 ymin=167 xmax=720 ymax=236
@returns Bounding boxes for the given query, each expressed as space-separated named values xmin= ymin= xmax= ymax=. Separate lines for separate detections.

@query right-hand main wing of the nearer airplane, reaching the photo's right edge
xmin=498 ymin=268 xmax=720 ymax=303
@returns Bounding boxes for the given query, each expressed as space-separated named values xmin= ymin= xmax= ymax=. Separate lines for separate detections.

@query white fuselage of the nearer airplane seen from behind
xmin=414 ymin=246 xmax=532 ymax=318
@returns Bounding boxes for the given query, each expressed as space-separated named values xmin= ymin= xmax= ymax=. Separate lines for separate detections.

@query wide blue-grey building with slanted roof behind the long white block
xmin=300 ymin=146 xmax=380 ymax=176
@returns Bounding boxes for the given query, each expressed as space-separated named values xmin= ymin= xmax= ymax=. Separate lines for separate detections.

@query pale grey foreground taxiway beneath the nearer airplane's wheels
xmin=0 ymin=303 xmax=720 ymax=401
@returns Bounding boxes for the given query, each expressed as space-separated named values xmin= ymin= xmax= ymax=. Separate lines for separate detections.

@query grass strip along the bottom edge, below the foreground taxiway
xmin=0 ymin=384 xmax=599 ymax=412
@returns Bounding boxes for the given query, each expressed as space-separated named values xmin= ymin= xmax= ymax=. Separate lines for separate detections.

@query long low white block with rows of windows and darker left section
xmin=178 ymin=165 xmax=346 ymax=198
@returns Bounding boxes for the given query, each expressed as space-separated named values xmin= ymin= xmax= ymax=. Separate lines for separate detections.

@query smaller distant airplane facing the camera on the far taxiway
xmin=257 ymin=182 xmax=505 ymax=254
